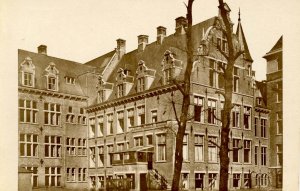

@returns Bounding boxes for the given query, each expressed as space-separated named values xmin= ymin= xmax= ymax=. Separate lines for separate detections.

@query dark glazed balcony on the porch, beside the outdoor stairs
xmin=112 ymin=146 xmax=154 ymax=165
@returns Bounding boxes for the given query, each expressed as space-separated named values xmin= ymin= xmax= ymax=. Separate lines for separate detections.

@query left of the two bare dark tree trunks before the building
xmin=172 ymin=0 xmax=194 ymax=191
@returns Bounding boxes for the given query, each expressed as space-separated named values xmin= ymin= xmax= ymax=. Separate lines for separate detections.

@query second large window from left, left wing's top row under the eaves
xmin=44 ymin=103 xmax=61 ymax=126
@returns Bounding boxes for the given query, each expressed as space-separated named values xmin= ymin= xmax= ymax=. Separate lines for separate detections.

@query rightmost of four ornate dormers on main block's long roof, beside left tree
xmin=162 ymin=50 xmax=182 ymax=84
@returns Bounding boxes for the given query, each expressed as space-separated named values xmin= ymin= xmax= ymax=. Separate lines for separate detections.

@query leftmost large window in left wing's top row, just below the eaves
xmin=19 ymin=99 xmax=38 ymax=123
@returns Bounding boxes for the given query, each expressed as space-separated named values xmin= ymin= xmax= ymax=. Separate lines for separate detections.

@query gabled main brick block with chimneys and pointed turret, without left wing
xmin=87 ymin=6 xmax=270 ymax=190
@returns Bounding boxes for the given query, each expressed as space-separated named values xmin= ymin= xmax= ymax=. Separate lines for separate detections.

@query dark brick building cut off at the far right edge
xmin=263 ymin=36 xmax=284 ymax=187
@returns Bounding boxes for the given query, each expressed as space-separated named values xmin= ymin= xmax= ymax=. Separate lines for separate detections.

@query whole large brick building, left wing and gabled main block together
xmin=19 ymin=5 xmax=271 ymax=190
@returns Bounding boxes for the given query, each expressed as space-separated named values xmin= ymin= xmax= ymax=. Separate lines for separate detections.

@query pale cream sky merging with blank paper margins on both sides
xmin=0 ymin=0 xmax=300 ymax=190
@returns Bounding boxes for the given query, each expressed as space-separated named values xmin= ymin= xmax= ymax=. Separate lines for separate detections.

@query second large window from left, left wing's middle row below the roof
xmin=44 ymin=135 xmax=62 ymax=158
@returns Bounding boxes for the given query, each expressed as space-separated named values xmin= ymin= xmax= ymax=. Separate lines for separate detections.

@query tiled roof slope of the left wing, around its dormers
xmin=18 ymin=49 xmax=95 ymax=96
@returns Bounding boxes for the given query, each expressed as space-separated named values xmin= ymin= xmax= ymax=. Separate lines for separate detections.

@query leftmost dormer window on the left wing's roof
xmin=20 ymin=57 xmax=35 ymax=87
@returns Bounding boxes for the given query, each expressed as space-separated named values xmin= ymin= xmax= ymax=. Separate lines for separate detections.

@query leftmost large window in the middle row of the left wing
xmin=19 ymin=134 xmax=39 ymax=157
